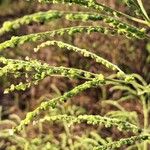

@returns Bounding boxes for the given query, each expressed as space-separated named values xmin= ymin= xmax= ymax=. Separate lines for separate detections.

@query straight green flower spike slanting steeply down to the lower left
xmin=14 ymin=75 xmax=105 ymax=132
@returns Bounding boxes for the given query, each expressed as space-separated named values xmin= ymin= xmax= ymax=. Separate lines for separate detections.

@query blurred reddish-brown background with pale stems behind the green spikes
xmin=0 ymin=0 xmax=150 ymax=150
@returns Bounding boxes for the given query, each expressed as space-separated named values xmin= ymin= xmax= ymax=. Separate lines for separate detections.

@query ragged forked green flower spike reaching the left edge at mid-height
xmin=0 ymin=57 xmax=98 ymax=93
